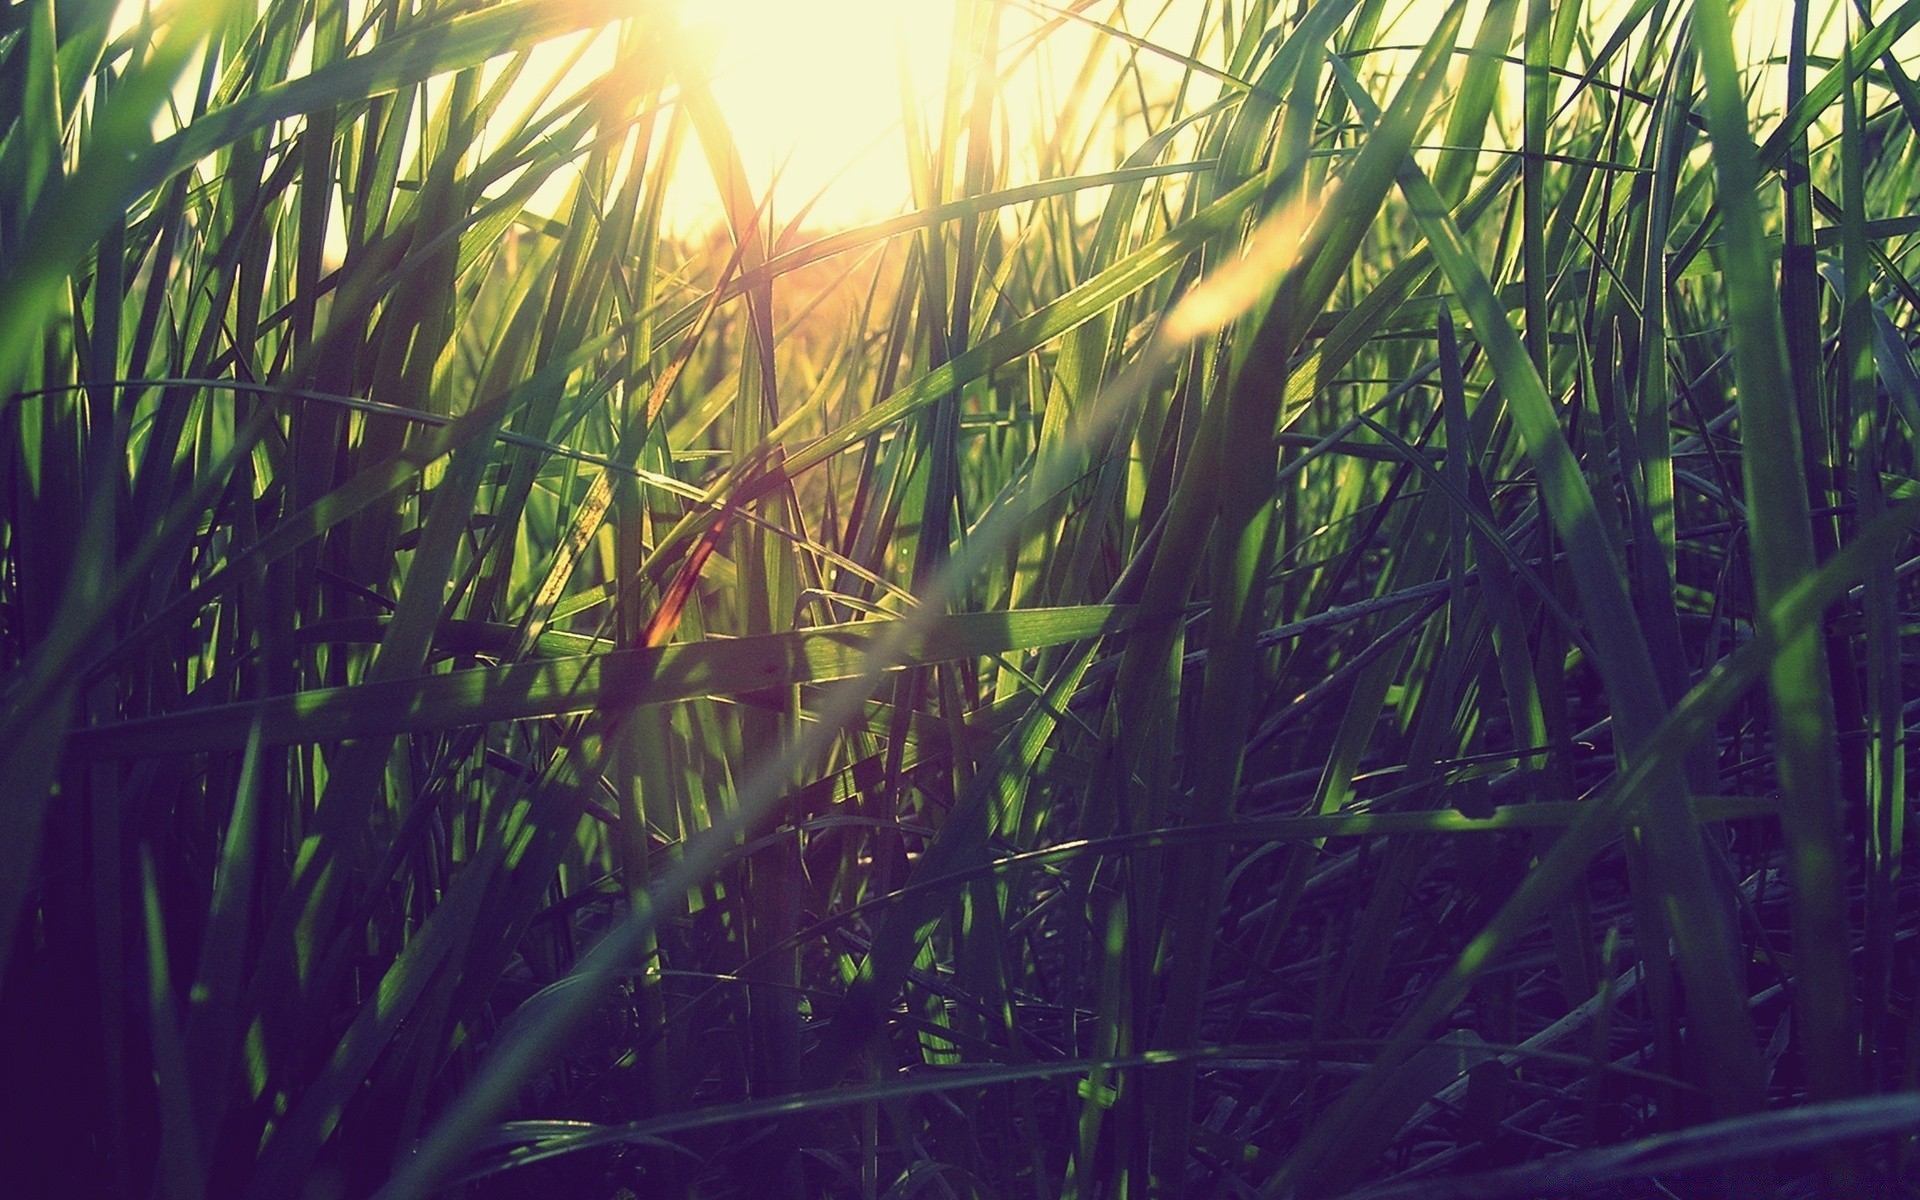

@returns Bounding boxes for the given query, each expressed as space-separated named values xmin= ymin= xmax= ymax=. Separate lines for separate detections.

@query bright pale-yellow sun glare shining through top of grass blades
xmin=680 ymin=0 xmax=954 ymax=225
